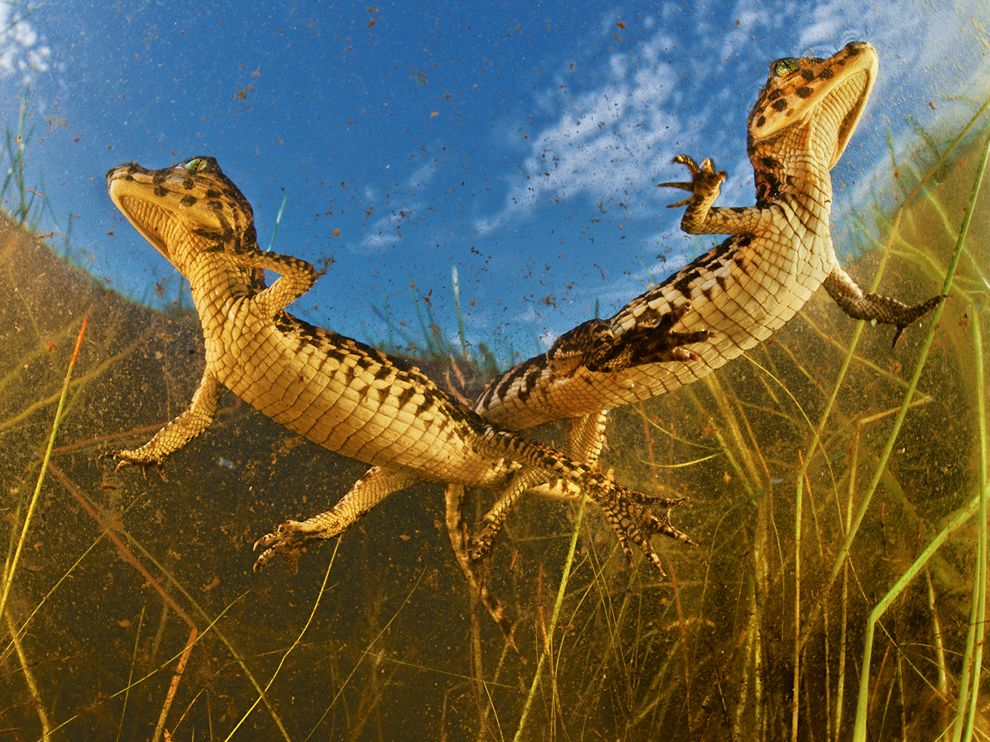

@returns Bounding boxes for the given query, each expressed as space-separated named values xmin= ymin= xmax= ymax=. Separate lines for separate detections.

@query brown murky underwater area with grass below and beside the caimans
xmin=0 ymin=81 xmax=990 ymax=740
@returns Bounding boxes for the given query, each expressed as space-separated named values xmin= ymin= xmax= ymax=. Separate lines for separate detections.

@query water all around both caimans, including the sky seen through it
xmin=0 ymin=0 xmax=990 ymax=740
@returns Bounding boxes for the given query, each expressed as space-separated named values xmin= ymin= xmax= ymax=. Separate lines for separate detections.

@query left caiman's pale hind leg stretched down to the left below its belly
xmin=254 ymin=466 xmax=420 ymax=572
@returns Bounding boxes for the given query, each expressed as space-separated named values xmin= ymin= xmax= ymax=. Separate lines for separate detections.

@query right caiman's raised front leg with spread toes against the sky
xmin=658 ymin=155 xmax=774 ymax=234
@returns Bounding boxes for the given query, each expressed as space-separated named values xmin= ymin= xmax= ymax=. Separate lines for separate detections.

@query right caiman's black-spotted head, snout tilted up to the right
xmin=747 ymin=41 xmax=878 ymax=201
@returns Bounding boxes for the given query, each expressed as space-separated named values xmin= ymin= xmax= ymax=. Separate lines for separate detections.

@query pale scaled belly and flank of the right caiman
xmin=484 ymin=224 xmax=834 ymax=429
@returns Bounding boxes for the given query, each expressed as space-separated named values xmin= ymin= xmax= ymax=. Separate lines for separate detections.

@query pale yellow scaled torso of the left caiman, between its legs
xmin=206 ymin=308 xmax=504 ymax=484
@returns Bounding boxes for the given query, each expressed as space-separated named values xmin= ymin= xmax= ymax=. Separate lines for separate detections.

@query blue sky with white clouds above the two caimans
xmin=0 ymin=0 xmax=990 ymax=362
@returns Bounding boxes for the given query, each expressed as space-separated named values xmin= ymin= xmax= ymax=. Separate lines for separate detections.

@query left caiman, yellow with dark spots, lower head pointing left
xmin=107 ymin=157 xmax=690 ymax=568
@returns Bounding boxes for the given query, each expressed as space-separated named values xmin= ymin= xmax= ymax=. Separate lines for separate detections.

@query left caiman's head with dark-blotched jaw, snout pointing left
xmin=107 ymin=157 xmax=258 ymax=278
